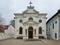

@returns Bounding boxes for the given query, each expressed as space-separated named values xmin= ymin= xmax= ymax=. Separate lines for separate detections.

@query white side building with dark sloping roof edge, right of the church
xmin=47 ymin=10 xmax=60 ymax=40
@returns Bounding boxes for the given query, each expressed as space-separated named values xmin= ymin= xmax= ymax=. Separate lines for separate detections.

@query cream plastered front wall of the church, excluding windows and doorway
xmin=15 ymin=7 xmax=47 ymax=38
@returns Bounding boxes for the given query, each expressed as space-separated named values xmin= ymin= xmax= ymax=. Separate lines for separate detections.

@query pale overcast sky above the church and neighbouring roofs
xmin=0 ymin=0 xmax=60 ymax=24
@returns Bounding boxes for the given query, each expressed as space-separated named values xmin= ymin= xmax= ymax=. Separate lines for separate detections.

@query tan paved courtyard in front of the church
xmin=0 ymin=39 xmax=60 ymax=45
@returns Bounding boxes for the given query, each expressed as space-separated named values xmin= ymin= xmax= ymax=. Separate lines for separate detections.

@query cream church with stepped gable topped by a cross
xmin=14 ymin=2 xmax=47 ymax=39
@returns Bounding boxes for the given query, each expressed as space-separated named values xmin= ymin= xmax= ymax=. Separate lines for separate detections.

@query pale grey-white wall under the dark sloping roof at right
xmin=47 ymin=16 xmax=59 ymax=40
